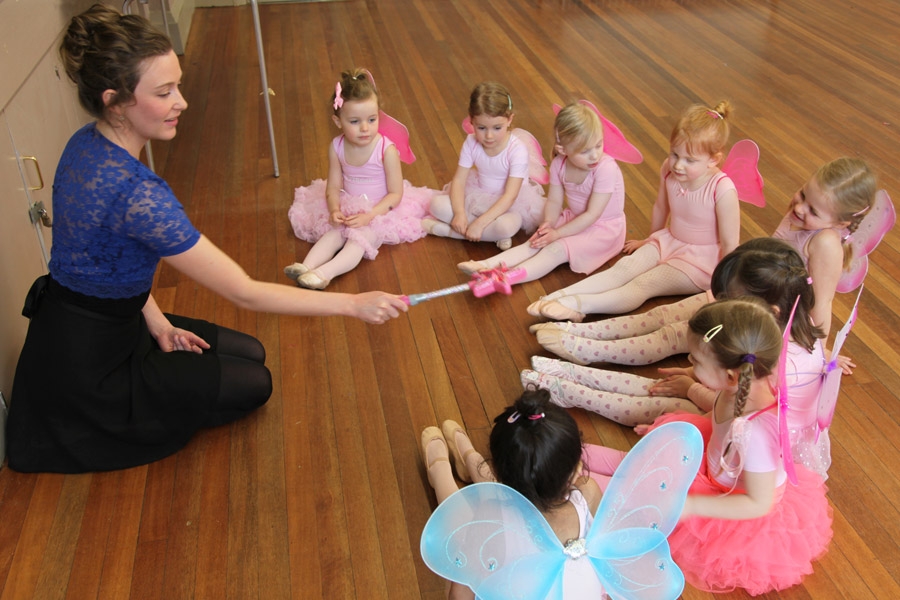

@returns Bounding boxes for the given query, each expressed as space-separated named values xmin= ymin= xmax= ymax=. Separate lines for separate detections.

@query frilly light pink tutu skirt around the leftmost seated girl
xmin=288 ymin=179 xmax=434 ymax=259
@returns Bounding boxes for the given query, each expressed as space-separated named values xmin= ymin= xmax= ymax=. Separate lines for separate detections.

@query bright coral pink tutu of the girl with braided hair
xmin=654 ymin=413 xmax=832 ymax=596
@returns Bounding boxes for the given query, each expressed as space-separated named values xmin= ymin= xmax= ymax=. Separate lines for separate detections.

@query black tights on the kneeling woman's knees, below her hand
xmin=207 ymin=326 xmax=272 ymax=427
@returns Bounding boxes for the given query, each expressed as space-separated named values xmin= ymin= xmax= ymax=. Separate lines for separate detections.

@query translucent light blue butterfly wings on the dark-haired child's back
xmin=421 ymin=423 xmax=703 ymax=600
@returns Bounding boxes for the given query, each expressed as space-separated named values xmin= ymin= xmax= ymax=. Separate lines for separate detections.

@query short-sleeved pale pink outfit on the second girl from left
xmin=444 ymin=134 xmax=544 ymax=233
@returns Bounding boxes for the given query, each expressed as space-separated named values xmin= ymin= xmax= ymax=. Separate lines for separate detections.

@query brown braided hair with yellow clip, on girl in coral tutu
xmin=688 ymin=296 xmax=781 ymax=417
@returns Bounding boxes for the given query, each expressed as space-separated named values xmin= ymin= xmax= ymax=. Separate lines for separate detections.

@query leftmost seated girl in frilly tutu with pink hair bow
xmin=284 ymin=69 xmax=433 ymax=290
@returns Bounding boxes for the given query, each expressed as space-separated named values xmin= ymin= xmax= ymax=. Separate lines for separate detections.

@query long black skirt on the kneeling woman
xmin=7 ymin=275 xmax=220 ymax=473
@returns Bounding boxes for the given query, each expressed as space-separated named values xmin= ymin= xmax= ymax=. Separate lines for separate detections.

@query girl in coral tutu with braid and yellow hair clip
xmin=584 ymin=298 xmax=832 ymax=595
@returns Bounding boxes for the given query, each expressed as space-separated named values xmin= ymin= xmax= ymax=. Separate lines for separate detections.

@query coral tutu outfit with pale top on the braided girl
xmin=654 ymin=410 xmax=833 ymax=596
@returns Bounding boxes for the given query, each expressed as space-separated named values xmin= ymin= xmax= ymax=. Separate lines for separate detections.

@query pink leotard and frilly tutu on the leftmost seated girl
xmin=288 ymin=135 xmax=434 ymax=259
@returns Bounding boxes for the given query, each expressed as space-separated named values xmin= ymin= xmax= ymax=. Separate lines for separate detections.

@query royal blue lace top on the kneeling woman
xmin=50 ymin=123 xmax=200 ymax=298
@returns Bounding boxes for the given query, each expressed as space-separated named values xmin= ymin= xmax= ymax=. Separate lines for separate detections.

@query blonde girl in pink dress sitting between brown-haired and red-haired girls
xmin=458 ymin=102 xmax=625 ymax=281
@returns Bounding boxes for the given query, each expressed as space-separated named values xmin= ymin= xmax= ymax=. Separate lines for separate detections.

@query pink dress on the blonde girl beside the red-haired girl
xmin=550 ymin=154 xmax=625 ymax=274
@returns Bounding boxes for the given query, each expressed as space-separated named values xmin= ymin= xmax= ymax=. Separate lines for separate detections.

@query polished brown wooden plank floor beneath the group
xmin=0 ymin=0 xmax=900 ymax=600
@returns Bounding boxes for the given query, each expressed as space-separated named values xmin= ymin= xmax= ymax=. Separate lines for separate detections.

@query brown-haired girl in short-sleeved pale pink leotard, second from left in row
xmin=422 ymin=81 xmax=546 ymax=250
